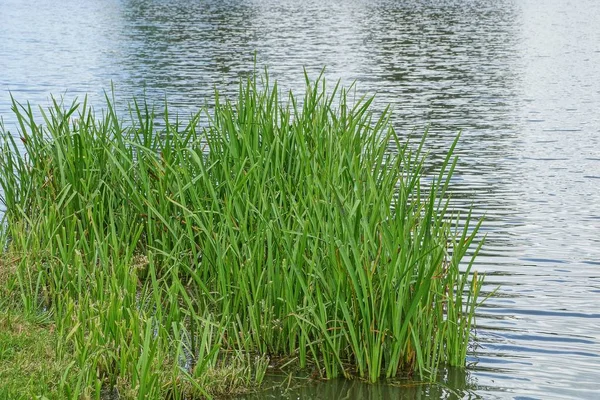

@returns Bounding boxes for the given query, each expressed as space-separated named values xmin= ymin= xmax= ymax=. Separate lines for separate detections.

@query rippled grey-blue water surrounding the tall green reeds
xmin=0 ymin=0 xmax=600 ymax=399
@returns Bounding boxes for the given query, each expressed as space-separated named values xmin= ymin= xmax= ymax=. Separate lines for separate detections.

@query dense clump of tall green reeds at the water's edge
xmin=0 ymin=73 xmax=481 ymax=399
